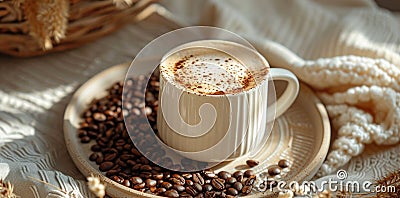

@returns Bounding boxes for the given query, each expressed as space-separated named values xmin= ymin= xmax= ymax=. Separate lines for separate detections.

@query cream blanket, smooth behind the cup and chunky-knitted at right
xmin=162 ymin=0 xmax=400 ymax=176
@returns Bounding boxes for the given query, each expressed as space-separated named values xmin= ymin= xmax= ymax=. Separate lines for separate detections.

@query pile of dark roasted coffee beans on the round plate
xmin=78 ymin=70 xmax=289 ymax=198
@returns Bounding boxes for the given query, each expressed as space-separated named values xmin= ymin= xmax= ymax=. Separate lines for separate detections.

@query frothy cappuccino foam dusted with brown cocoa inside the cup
xmin=160 ymin=48 xmax=268 ymax=95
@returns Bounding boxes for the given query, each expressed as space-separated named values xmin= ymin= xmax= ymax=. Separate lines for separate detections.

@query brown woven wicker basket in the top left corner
xmin=0 ymin=0 xmax=157 ymax=57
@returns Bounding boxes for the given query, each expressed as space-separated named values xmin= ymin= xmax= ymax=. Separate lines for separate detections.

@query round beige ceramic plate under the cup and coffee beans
xmin=64 ymin=64 xmax=331 ymax=197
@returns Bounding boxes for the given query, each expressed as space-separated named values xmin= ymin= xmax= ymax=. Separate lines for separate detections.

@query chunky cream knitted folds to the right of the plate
xmin=292 ymin=56 xmax=400 ymax=176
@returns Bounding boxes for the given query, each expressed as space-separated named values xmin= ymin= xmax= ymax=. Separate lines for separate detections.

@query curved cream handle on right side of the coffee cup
xmin=268 ymin=68 xmax=300 ymax=121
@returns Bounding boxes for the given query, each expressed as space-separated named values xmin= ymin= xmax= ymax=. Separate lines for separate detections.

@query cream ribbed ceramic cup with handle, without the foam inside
xmin=157 ymin=40 xmax=299 ymax=162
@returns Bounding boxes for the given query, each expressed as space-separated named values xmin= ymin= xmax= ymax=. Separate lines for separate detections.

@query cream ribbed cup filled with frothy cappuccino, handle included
xmin=157 ymin=40 xmax=299 ymax=163
